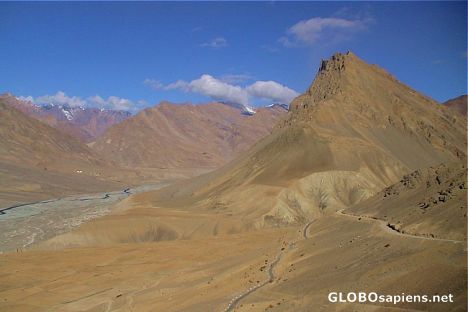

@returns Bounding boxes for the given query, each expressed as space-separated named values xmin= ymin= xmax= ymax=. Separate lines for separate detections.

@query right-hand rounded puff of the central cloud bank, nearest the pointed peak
xmin=246 ymin=81 xmax=299 ymax=104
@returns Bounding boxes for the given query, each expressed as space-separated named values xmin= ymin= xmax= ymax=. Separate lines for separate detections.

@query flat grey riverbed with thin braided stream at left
xmin=0 ymin=182 xmax=167 ymax=252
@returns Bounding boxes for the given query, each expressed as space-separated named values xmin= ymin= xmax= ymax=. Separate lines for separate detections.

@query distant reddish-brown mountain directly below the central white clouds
xmin=92 ymin=102 xmax=286 ymax=168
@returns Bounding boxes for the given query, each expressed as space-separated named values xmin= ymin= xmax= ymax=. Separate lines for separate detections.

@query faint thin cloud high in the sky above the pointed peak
xmin=278 ymin=17 xmax=370 ymax=47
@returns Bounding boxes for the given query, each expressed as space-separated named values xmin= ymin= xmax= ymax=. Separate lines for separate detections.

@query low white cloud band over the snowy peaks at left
xmin=18 ymin=91 xmax=133 ymax=110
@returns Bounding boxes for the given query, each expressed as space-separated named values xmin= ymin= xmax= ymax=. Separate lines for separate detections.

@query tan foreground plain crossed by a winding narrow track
xmin=0 ymin=206 xmax=467 ymax=311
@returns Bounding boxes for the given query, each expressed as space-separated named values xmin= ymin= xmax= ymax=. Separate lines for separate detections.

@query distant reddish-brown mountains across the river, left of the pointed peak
xmin=0 ymin=94 xmax=287 ymax=205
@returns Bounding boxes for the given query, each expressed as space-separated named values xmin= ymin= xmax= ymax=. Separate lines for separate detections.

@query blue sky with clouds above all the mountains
xmin=0 ymin=2 xmax=467 ymax=110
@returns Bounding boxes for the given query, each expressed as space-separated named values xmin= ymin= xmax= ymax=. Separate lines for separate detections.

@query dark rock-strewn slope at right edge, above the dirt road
xmin=346 ymin=164 xmax=467 ymax=240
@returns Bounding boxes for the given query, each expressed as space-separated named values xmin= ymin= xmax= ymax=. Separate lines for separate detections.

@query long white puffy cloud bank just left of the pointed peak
xmin=143 ymin=74 xmax=299 ymax=108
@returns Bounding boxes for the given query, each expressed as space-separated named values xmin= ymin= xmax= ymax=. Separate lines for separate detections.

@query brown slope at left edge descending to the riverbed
xmin=0 ymin=100 xmax=134 ymax=207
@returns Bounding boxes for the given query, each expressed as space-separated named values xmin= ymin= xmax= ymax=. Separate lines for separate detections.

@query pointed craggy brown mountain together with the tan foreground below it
xmin=5 ymin=54 xmax=467 ymax=311
